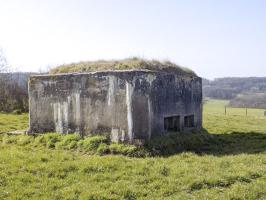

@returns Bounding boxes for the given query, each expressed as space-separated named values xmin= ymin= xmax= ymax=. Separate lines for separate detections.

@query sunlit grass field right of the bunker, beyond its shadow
xmin=203 ymin=100 xmax=266 ymax=134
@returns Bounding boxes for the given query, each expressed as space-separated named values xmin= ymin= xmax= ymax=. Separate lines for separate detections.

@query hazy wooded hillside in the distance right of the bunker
xmin=203 ymin=77 xmax=266 ymax=109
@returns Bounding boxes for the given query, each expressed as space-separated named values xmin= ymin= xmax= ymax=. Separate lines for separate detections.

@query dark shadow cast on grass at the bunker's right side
xmin=145 ymin=130 xmax=266 ymax=156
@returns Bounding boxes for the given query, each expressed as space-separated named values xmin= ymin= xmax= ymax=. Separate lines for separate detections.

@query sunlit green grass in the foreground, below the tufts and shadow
xmin=0 ymin=145 xmax=266 ymax=199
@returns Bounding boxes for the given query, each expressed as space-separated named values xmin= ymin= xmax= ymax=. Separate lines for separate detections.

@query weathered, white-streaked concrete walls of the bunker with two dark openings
xmin=29 ymin=70 xmax=202 ymax=143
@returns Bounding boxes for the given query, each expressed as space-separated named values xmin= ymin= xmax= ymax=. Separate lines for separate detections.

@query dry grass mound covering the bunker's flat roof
xmin=50 ymin=58 xmax=196 ymax=76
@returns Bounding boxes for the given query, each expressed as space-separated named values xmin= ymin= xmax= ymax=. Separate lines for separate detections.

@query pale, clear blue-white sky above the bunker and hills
xmin=0 ymin=0 xmax=266 ymax=78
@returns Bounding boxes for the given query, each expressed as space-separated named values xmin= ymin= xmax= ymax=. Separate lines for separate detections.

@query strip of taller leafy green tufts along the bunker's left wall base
xmin=1 ymin=133 xmax=163 ymax=157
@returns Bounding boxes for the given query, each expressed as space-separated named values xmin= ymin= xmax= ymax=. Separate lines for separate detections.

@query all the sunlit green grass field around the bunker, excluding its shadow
xmin=0 ymin=101 xmax=266 ymax=200
